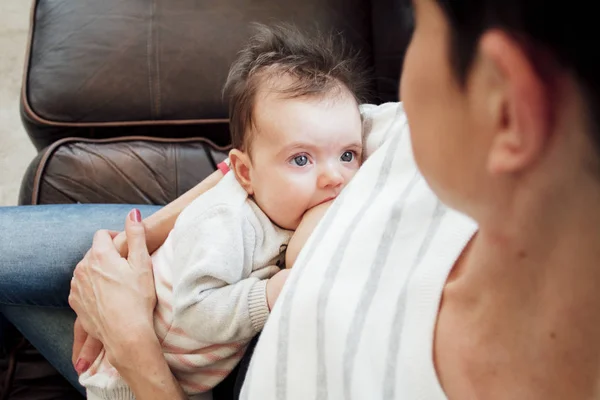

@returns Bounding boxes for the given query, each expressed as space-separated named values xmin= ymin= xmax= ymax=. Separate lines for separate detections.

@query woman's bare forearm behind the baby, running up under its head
xmin=113 ymin=170 xmax=223 ymax=257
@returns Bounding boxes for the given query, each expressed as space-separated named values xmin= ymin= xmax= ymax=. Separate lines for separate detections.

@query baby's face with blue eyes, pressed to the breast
xmin=250 ymin=91 xmax=362 ymax=230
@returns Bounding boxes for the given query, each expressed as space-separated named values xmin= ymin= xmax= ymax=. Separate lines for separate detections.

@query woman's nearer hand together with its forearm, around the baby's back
xmin=69 ymin=210 xmax=187 ymax=400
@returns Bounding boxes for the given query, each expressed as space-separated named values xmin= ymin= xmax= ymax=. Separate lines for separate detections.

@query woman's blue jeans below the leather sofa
xmin=0 ymin=204 xmax=160 ymax=393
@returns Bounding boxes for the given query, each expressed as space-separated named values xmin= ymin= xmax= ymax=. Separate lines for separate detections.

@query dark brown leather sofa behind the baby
xmin=4 ymin=0 xmax=412 ymax=398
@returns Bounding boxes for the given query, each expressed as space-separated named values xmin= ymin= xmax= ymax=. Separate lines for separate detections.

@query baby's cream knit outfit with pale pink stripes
xmin=80 ymin=173 xmax=291 ymax=400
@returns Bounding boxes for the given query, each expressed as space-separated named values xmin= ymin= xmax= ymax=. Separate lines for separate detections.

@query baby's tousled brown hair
xmin=223 ymin=24 xmax=367 ymax=151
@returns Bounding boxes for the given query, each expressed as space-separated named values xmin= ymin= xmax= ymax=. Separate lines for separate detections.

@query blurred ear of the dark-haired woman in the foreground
xmin=479 ymin=30 xmax=551 ymax=174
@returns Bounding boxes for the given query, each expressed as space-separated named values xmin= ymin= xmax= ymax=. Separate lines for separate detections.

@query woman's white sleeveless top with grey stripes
xmin=242 ymin=103 xmax=476 ymax=400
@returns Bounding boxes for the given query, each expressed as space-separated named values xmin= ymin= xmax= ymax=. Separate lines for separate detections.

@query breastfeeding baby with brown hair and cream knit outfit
xmin=80 ymin=26 xmax=363 ymax=400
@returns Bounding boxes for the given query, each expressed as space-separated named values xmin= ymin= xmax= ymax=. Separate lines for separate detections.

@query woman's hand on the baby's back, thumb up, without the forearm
xmin=69 ymin=210 xmax=156 ymax=364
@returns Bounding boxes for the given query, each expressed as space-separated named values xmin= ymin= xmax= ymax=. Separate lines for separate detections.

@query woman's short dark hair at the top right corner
xmin=436 ymin=0 xmax=600 ymax=151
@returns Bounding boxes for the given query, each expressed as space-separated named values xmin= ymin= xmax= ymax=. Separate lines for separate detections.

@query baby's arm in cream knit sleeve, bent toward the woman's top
xmin=168 ymin=206 xmax=279 ymax=344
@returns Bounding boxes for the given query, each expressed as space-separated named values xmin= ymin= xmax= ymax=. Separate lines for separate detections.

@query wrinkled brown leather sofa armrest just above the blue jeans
xmin=19 ymin=137 xmax=227 ymax=205
